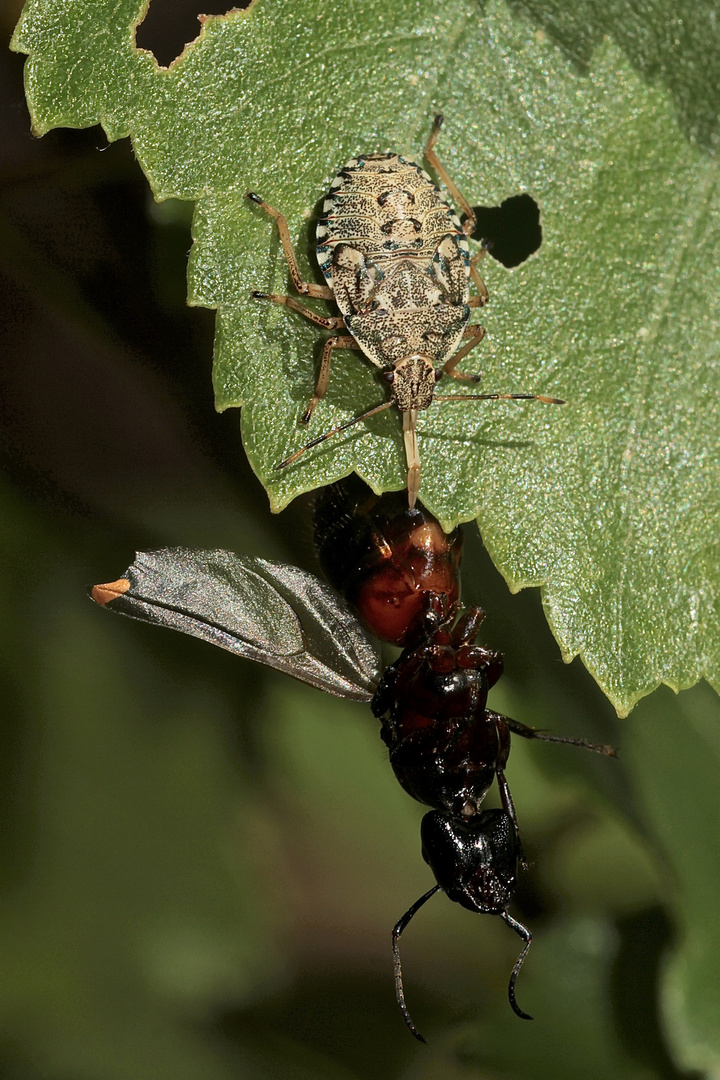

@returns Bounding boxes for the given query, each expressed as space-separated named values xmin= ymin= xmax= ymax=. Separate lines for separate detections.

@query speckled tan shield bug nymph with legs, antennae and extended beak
xmin=247 ymin=116 xmax=565 ymax=507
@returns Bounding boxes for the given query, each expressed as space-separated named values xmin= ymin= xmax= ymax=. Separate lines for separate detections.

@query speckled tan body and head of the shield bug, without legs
xmin=317 ymin=153 xmax=470 ymax=409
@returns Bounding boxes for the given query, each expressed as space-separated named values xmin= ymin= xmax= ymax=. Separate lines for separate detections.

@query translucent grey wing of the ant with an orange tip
xmin=89 ymin=548 xmax=380 ymax=701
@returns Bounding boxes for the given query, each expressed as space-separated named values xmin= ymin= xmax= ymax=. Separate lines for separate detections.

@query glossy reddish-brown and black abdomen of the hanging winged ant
xmin=314 ymin=476 xmax=463 ymax=645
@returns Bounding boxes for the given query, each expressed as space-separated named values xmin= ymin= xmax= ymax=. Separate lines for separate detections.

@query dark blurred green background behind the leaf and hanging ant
xmin=0 ymin=0 xmax=699 ymax=1080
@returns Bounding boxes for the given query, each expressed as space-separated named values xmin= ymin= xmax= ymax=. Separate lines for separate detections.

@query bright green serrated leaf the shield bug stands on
xmin=13 ymin=0 xmax=720 ymax=714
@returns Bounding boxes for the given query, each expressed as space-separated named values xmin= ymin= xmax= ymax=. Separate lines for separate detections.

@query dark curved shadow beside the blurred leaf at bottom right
xmin=610 ymin=907 xmax=703 ymax=1080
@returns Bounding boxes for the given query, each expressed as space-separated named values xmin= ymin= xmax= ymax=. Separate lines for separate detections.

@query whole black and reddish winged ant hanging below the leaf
xmin=90 ymin=477 xmax=615 ymax=1042
